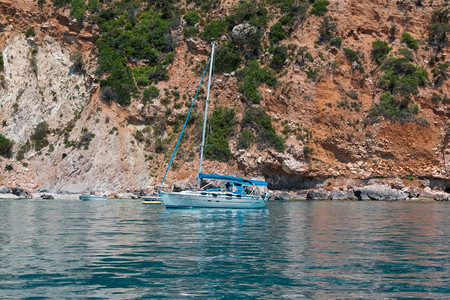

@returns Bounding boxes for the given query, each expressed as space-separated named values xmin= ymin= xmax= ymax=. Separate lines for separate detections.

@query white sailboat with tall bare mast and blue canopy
xmin=160 ymin=43 xmax=270 ymax=208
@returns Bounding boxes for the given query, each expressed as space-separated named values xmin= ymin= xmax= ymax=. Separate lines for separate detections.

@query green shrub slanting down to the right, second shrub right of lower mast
xmin=242 ymin=107 xmax=284 ymax=152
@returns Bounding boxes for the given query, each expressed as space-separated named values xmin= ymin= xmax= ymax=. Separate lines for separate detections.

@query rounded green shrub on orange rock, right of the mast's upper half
xmin=237 ymin=60 xmax=276 ymax=103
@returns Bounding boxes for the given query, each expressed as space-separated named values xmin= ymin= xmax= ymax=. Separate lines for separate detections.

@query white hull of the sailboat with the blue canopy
xmin=161 ymin=191 xmax=266 ymax=208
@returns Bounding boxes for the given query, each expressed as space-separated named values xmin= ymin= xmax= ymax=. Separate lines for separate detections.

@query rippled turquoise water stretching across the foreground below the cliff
xmin=0 ymin=200 xmax=450 ymax=299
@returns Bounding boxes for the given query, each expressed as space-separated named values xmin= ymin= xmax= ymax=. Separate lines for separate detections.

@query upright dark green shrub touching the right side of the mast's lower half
xmin=205 ymin=106 xmax=235 ymax=161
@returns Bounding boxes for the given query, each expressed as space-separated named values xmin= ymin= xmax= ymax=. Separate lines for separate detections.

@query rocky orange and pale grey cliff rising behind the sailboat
xmin=0 ymin=0 xmax=450 ymax=192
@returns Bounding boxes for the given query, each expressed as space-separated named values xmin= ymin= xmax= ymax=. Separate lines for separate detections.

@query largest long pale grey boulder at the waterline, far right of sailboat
xmin=353 ymin=184 xmax=409 ymax=200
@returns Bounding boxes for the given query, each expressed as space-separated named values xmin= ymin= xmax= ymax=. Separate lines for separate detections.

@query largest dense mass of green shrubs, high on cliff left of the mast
xmin=96 ymin=9 xmax=175 ymax=105
